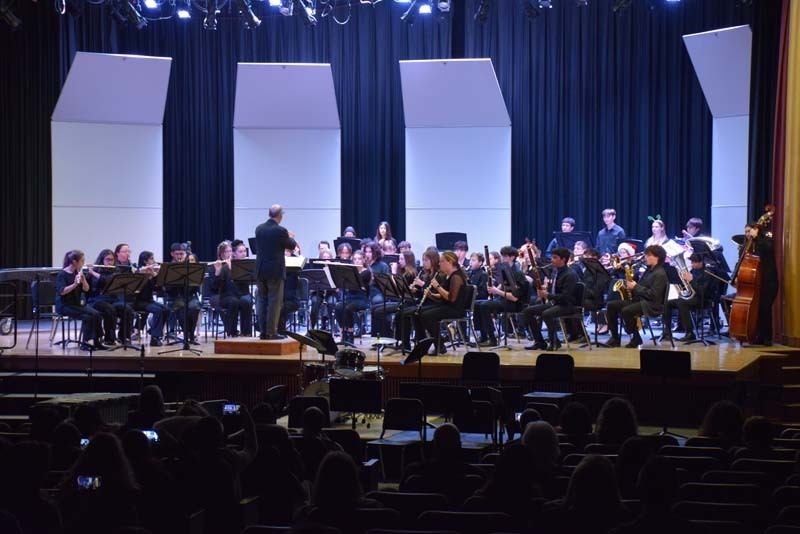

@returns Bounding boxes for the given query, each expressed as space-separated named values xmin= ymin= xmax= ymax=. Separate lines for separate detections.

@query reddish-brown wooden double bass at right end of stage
xmin=729 ymin=204 xmax=775 ymax=343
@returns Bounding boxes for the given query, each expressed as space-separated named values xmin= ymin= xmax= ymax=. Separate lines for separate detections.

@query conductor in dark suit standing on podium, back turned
xmin=256 ymin=204 xmax=297 ymax=339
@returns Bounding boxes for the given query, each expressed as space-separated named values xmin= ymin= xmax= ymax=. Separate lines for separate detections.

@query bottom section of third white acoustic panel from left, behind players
xmin=406 ymin=207 xmax=511 ymax=255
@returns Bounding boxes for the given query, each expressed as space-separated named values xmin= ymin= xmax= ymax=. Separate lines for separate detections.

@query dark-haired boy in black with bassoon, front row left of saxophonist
xmin=523 ymin=247 xmax=580 ymax=350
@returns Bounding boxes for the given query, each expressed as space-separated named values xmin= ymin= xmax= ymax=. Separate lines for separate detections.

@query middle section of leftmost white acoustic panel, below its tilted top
xmin=51 ymin=122 xmax=163 ymax=209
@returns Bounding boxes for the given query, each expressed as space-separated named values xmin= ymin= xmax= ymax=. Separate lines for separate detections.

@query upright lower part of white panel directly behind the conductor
xmin=233 ymin=128 xmax=341 ymax=252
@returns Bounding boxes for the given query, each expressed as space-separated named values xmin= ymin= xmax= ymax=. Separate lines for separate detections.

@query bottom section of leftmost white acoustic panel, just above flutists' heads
xmin=53 ymin=207 xmax=164 ymax=267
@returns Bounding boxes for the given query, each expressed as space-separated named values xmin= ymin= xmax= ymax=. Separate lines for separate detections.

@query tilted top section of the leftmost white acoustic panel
xmin=53 ymin=52 xmax=172 ymax=124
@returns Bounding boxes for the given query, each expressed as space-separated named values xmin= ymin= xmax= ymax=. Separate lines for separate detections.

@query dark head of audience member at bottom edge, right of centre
xmin=564 ymin=455 xmax=620 ymax=511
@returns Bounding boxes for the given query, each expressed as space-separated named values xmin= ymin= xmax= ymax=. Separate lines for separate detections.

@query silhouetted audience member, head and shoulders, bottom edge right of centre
xmin=543 ymin=455 xmax=630 ymax=534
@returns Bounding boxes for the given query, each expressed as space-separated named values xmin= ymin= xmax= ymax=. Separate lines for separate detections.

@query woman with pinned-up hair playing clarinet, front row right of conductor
xmin=415 ymin=250 xmax=469 ymax=354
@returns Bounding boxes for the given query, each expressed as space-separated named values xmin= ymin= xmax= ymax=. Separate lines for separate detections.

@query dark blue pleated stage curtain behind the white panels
xmin=0 ymin=0 xmax=764 ymax=266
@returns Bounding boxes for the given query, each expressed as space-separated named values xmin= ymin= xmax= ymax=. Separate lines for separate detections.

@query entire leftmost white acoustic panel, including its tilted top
xmin=52 ymin=53 xmax=172 ymax=266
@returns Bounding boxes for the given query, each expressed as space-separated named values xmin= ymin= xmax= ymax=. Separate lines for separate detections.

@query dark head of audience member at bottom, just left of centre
xmin=312 ymin=451 xmax=362 ymax=512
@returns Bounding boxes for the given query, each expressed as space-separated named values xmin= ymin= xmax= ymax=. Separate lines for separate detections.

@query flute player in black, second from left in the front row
xmin=88 ymin=249 xmax=133 ymax=345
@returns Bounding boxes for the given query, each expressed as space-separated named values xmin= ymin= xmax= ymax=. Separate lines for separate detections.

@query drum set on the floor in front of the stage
xmin=303 ymin=348 xmax=386 ymax=399
